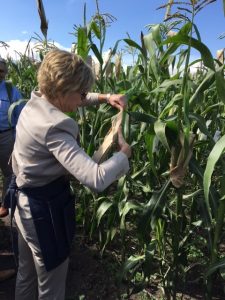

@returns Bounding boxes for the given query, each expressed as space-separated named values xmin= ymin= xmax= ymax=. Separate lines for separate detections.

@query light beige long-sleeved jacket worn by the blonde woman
xmin=12 ymin=92 xmax=129 ymax=191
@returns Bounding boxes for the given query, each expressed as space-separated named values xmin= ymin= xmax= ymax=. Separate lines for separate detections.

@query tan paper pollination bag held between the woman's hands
xmin=92 ymin=110 xmax=123 ymax=163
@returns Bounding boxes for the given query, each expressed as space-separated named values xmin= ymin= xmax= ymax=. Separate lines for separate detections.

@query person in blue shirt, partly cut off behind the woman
xmin=0 ymin=57 xmax=22 ymax=218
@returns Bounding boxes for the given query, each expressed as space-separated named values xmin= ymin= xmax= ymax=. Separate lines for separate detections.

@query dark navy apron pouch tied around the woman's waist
xmin=19 ymin=177 xmax=75 ymax=271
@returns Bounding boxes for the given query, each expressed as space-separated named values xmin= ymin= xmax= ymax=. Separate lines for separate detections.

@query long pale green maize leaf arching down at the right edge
xmin=203 ymin=135 xmax=225 ymax=209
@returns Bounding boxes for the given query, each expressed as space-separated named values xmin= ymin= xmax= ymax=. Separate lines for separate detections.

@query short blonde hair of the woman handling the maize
xmin=38 ymin=49 xmax=94 ymax=101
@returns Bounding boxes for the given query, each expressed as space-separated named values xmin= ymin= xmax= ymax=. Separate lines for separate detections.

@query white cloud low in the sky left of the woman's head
xmin=0 ymin=40 xmax=70 ymax=60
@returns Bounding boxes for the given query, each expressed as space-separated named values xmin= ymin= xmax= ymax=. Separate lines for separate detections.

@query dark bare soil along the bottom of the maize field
xmin=0 ymin=217 xmax=225 ymax=300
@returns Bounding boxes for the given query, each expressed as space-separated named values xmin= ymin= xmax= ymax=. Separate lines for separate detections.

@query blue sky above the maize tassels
xmin=0 ymin=0 xmax=225 ymax=62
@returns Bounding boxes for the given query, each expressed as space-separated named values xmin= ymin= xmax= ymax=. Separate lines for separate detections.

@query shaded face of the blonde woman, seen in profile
xmin=58 ymin=92 xmax=87 ymax=112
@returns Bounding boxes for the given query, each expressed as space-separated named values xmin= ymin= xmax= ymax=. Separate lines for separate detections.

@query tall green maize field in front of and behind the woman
xmin=1 ymin=0 xmax=225 ymax=300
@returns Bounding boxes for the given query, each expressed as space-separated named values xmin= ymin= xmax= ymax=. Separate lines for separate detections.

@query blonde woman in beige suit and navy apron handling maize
xmin=12 ymin=50 xmax=131 ymax=300
